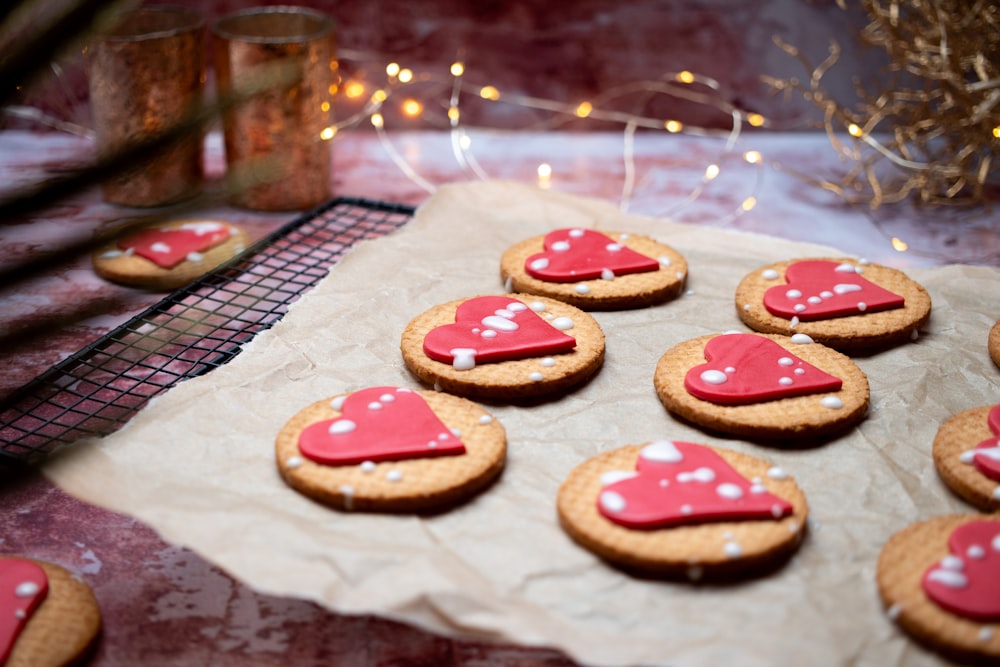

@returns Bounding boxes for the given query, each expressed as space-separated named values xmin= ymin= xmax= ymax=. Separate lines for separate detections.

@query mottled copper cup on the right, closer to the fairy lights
xmin=212 ymin=6 xmax=337 ymax=211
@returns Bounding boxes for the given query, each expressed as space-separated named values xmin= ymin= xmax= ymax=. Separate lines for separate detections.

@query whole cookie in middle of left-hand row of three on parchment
xmin=400 ymin=294 xmax=604 ymax=400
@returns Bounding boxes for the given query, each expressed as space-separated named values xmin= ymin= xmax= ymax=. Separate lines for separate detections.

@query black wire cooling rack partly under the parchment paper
xmin=0 ymin=198 xmax=414 ymax=462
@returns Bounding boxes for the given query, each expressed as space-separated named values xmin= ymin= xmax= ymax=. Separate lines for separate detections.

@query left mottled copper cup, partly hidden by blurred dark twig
xmin=87 ymin=6 xmax=205 ymax=206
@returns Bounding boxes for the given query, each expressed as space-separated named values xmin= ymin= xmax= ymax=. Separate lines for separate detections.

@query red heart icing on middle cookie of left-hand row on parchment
xmin=424 ymin=296 xmax=576 ymax=370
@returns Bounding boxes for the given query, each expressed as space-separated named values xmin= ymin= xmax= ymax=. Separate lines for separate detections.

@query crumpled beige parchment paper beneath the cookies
xmin=45 ymin=182 xmax=1000 ymax=666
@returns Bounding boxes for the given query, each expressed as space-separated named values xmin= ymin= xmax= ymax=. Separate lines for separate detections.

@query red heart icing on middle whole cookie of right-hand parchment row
xmin=684 ymin=333 xmax=843 ymax=405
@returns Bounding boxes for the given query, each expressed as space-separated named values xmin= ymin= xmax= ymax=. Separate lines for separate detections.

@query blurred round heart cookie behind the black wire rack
xmin=92 ymin=220 xmax=249 ymax=291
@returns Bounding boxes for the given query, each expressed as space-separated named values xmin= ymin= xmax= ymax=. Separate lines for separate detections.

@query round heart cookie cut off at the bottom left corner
xmin=0 ymin=557 xmax=101 ymax=667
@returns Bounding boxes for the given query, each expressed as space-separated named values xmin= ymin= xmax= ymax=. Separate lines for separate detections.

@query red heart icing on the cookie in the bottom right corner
xmin=921 ymin=521 xmax=1000 ymax=621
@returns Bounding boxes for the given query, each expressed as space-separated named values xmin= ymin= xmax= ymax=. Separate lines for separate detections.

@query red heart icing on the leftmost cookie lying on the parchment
xmin=299 ymin=387 xmax=465 ymax=465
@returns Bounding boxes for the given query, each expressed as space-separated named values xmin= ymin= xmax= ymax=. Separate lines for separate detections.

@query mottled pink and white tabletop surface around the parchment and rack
xmin=0 ymin=128 xmax=1000 ymax=666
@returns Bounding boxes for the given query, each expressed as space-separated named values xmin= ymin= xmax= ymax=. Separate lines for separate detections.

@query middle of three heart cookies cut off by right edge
xmin=931 ymin=405 xmax=1000 ymax=512
